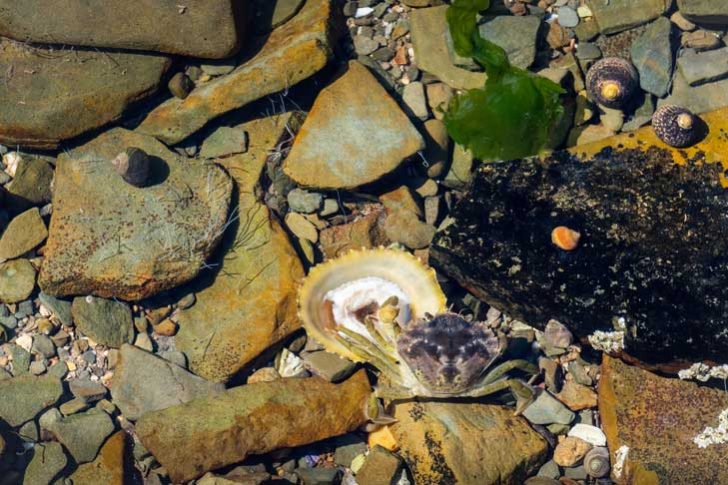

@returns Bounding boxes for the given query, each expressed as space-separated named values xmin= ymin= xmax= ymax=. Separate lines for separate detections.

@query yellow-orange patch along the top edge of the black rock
xmin=568 ymin=108 xmax=728 ymax=188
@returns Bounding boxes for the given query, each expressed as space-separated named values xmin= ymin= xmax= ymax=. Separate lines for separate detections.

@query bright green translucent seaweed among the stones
xmin=444 ymin=0 xmax=564 ymax=160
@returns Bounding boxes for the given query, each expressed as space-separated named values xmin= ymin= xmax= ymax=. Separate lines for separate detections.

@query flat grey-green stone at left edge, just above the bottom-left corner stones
xmin=0 ymin=375 xmax=63 ymax=427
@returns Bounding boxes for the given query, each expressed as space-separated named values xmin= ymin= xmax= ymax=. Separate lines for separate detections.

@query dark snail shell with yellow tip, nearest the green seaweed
xmin=586 ymin=57 xmax=639 ymax=109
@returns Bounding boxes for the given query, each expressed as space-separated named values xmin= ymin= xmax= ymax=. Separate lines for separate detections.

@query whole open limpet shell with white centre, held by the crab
xmin=299 ymin=249 xmax=446 ymax=362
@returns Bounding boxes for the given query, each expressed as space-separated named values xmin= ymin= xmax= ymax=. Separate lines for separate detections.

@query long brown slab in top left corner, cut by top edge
xmin=0 ymin=0 xmax=243 ymax=59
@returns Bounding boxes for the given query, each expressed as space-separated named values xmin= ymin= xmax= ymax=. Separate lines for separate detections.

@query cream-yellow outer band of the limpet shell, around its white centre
xmin=298 ymin=248 xmax=446 ymax=362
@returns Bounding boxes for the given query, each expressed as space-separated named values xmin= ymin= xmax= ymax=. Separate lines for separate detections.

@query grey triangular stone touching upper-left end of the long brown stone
xmin=111 ymin=345 xmax=225 ymax=421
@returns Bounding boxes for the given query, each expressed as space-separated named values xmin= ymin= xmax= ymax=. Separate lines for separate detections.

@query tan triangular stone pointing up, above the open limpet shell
xmin=283 ymin=61 xmax=425 ymax=189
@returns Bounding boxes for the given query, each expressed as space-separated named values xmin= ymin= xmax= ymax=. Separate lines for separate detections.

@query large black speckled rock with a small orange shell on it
xmin=430 ymin=147 xmax=728 ymax=363
